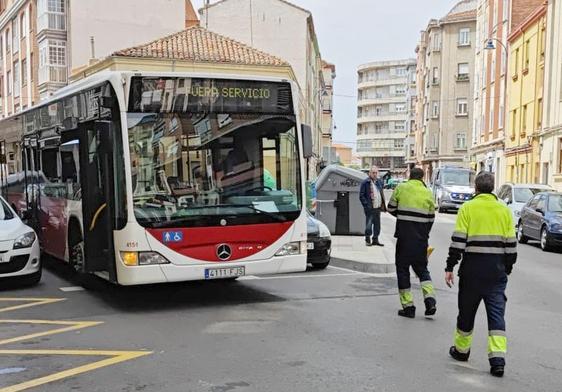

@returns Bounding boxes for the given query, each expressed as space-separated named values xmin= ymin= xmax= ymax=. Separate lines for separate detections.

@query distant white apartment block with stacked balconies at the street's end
xmin=357 ymin=59 xmax=416 ymax=171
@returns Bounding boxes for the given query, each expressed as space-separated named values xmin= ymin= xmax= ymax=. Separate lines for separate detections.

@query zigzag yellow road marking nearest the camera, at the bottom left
xmin=0 ymin=350 xmax=152 ymax=392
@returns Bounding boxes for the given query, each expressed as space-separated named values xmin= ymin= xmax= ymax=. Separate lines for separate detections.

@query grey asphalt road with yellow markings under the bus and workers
xmin=0 ymin=215 xmax=562 ymax=392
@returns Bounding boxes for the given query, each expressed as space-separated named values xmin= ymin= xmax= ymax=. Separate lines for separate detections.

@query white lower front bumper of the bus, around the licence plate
xmin=117 ymin=254 xmax=306 ymax=286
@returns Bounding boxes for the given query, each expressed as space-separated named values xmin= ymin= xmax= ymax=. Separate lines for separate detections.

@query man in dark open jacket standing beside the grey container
xmin=359 ymin=166 xmax=386 ymax=246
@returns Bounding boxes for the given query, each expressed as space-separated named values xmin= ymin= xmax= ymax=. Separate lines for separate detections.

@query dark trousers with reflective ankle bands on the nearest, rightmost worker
xmin=457 ymin=254 xmax=507 ymax=366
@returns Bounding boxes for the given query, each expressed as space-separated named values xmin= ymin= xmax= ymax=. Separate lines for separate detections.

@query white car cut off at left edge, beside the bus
xmin=0 ymin=197 xmax=41 ymax=284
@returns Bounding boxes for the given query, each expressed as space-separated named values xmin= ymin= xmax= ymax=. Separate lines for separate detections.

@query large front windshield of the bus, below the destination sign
xmin=127 ymin=113 xmax=301 ymax=228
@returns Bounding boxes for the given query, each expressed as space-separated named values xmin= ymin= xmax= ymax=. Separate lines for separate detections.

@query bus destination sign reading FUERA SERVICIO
xmin=129 ymin=77 xmax=293 ymax=114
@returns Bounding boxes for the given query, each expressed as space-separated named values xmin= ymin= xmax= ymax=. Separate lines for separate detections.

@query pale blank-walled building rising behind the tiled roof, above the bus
xmin=199 ymin=0 xmax=324 ymax=180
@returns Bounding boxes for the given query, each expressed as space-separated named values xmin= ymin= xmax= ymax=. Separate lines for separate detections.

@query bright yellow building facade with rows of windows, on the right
xmin=505 ymin=5 xmax=547 ymax=183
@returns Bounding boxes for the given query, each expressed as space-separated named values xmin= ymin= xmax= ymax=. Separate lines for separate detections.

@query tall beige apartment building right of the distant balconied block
xmin=416 ymin=0 xmax=477 ymax=178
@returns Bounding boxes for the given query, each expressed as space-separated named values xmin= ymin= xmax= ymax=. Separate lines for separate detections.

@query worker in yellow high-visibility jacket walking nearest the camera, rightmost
xmin=445 ymin=172 xmax=517 ymax=377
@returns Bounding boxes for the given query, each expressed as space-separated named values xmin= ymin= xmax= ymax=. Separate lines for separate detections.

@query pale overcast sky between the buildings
xmin=192 ymin=0 xmax=457 ymax=147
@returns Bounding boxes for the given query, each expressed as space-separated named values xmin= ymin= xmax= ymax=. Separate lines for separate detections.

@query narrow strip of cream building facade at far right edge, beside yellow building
xmin=539 ymin=0 xmax=562 ymax=192
